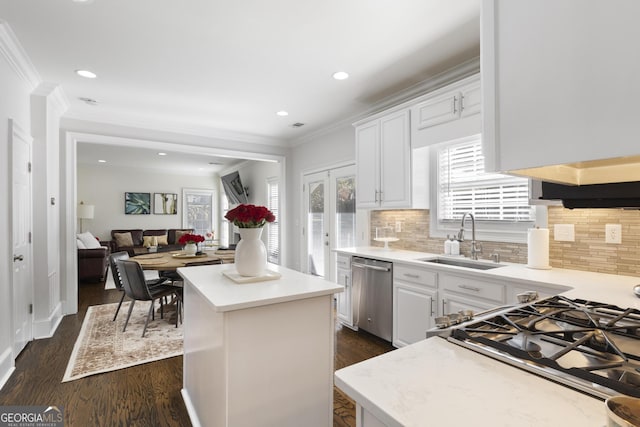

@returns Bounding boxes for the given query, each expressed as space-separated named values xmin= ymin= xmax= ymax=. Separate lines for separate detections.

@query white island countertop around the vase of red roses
xmin=178 ymin=264 xmax=344 ymax=312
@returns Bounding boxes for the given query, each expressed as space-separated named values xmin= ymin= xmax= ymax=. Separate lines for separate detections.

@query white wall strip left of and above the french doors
xmin=285 ymin=124 xmax=357 ymax=270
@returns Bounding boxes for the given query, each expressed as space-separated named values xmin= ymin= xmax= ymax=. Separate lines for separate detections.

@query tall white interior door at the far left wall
xmin=9 ymin=120 xmax=33 ymax=358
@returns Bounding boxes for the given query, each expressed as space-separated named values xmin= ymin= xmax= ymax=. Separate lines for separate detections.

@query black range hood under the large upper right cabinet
xmin=532 ymin=181 xmax=640 ymax=209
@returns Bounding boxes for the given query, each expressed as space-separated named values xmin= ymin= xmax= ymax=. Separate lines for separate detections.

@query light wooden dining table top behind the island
xmin=130 ymin=250 xmax=235 ymax=271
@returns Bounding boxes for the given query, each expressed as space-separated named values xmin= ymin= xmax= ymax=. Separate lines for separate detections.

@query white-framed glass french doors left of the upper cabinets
xmin=302 ymin=165 xmax=356 ymax=280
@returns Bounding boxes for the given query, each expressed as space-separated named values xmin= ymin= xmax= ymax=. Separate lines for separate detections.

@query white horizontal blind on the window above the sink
xmin=437 ymin=137 xmax=535 ymax=223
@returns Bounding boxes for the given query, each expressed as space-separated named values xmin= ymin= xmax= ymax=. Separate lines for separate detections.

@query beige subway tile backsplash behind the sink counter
xmin=370 ymin=206 xmax=640 ymax=276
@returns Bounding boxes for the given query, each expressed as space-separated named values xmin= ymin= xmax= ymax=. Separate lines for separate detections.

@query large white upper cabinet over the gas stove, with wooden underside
xmin=481 ymin=0 xmax=640 ymax=184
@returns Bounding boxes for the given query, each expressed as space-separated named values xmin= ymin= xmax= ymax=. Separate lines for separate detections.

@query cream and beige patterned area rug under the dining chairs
xmin=62 ymin=301 xmax=183 ymax=382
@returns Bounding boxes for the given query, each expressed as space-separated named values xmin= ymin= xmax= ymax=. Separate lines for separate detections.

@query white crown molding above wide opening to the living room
xmin=64 ymin=106 xmax=289 ymax=148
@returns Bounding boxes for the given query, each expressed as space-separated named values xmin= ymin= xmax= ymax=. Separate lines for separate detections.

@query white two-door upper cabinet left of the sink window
xmin=356 ymin=110 xmax=411 ymax=208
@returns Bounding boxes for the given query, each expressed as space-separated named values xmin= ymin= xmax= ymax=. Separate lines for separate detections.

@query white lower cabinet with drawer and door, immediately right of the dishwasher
xmin=392 ymin=264 xmax=437 ymax=347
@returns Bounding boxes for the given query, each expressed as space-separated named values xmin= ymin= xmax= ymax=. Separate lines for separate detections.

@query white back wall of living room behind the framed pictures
xmin=77 ymin=164 xmax=218 ymax=241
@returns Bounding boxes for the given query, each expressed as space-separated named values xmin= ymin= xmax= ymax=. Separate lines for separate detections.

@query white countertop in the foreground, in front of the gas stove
xmin=335 ymin=337 xmax=606 ymax=427
